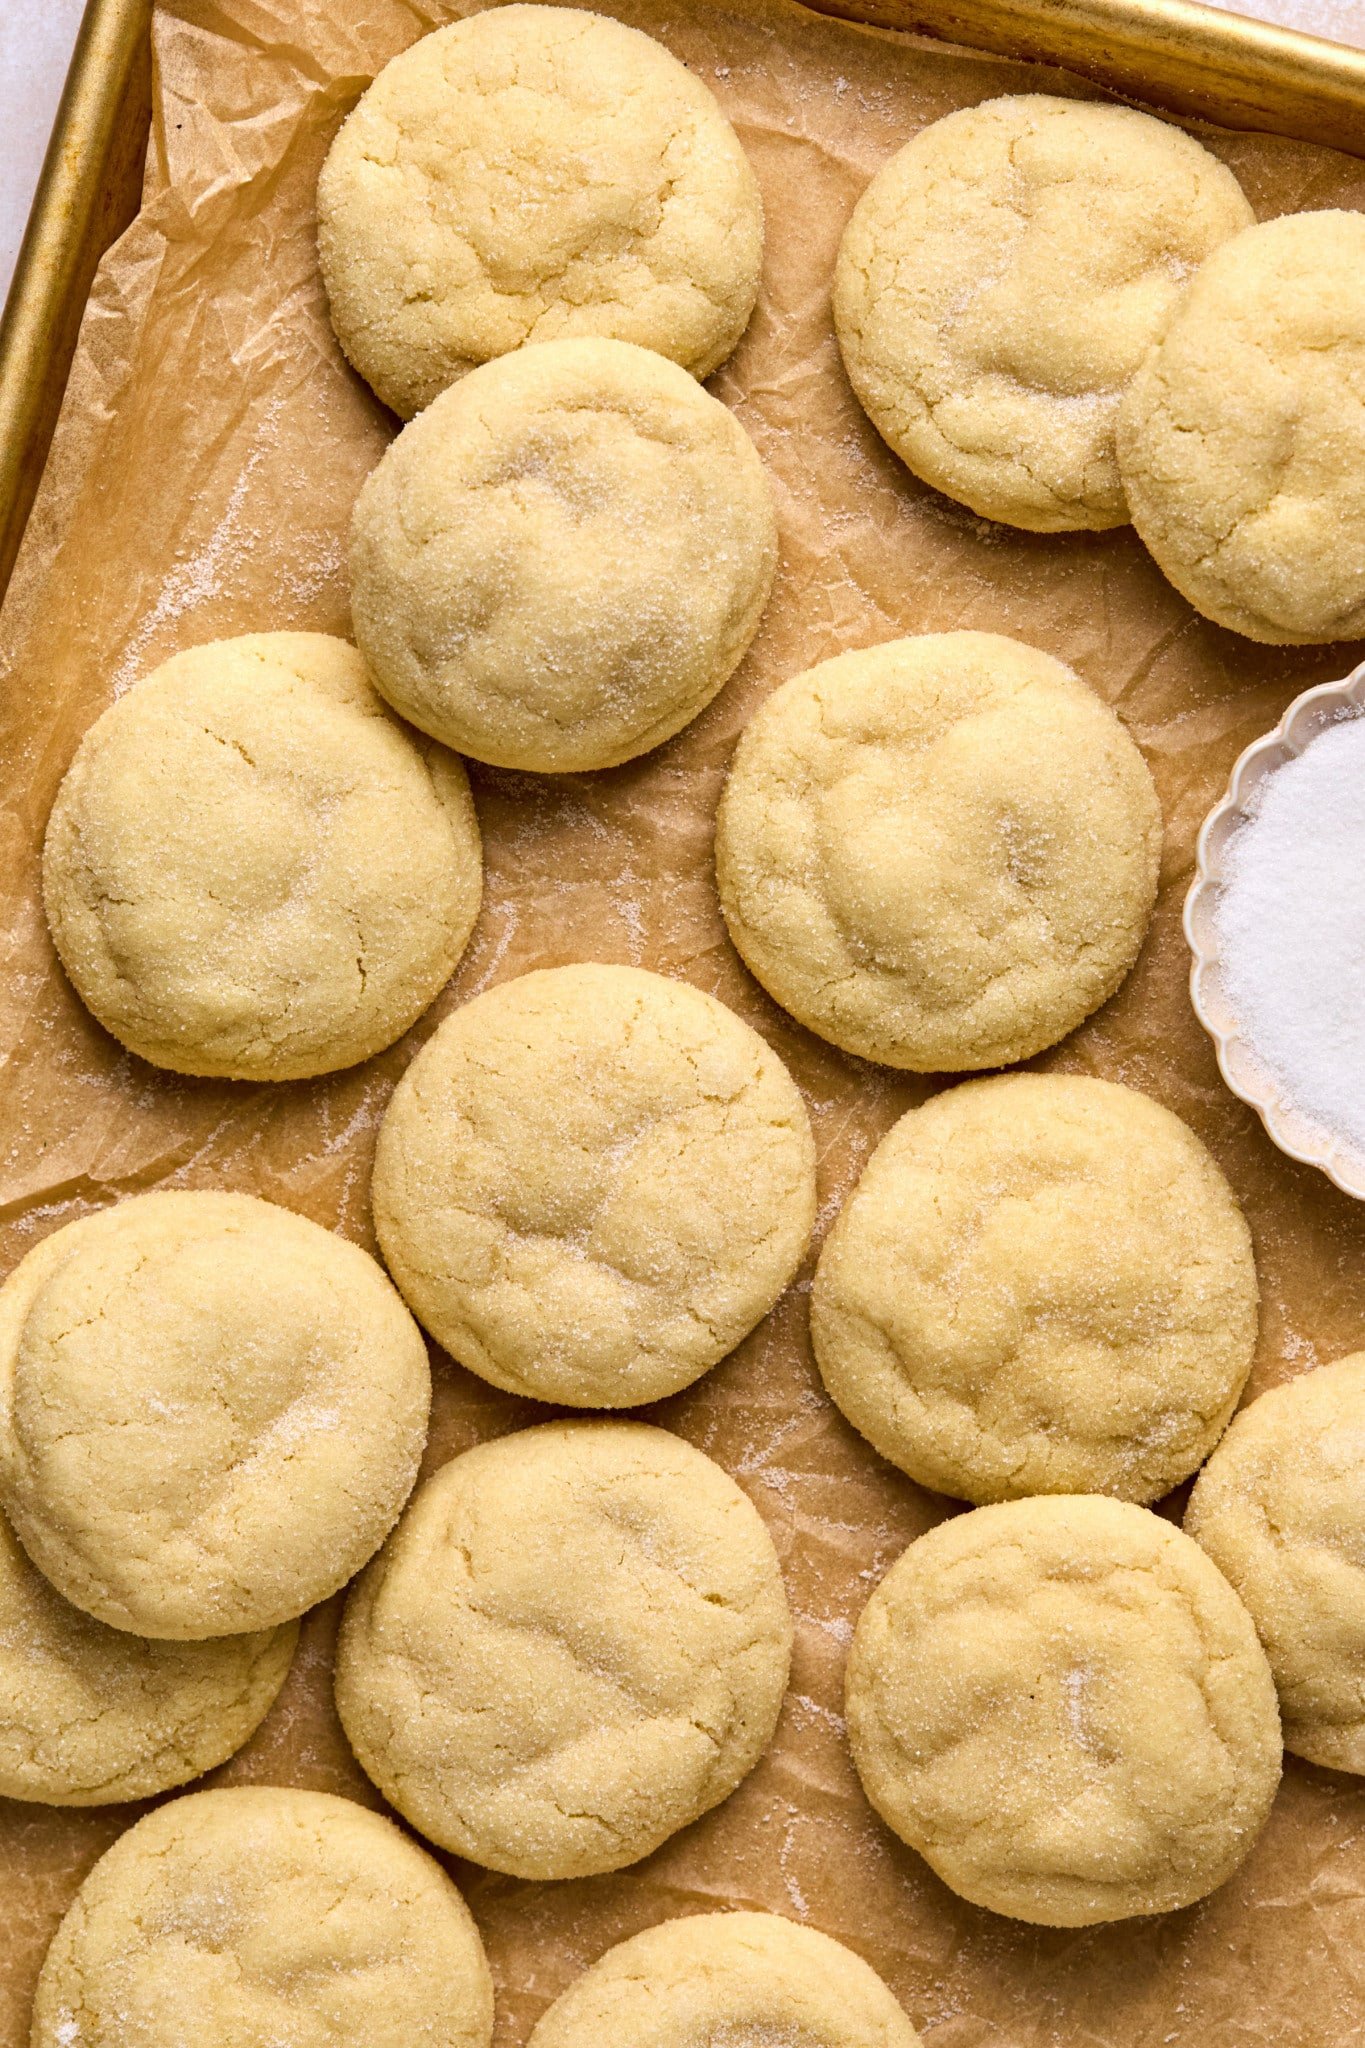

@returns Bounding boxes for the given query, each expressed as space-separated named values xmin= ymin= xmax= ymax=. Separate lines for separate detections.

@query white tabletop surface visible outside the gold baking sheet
xmin=0 ymin=0 xmax=1365 ymax=297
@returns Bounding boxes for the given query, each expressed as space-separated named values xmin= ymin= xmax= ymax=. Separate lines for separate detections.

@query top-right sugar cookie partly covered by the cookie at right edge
xmin=835 ymin=94 xmax=1254 ymax=532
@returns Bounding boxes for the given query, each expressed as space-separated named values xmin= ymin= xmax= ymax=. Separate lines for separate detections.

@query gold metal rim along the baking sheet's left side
xmin=0 ymin=0 xmax=151 ymax=598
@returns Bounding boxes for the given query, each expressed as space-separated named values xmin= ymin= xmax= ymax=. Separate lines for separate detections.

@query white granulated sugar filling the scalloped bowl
xmin=1216 ymin=717 xmax=1365 ymax=1149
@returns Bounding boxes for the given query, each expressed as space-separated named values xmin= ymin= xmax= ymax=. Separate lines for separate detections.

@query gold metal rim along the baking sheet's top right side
xmin=806 ymin=0 xmax=1365 ymax=156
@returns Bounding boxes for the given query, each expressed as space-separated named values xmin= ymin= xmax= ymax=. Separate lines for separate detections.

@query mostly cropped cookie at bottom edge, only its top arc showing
xmin=526 ymin=1913 xmax=921 ymax=2048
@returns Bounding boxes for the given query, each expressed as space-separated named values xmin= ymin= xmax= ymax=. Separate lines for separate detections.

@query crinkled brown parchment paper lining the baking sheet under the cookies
xmin=0 ymin=0 xmax=1365 ymax=2048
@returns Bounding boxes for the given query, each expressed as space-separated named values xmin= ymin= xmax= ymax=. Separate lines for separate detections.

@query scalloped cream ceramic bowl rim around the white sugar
xmin=1185 ymin=664 xmax=1365 ymax=1200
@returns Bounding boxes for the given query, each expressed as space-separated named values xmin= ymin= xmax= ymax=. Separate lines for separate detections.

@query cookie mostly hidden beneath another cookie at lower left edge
xmin=0 ymin=1516 xmax=299 ymax=1806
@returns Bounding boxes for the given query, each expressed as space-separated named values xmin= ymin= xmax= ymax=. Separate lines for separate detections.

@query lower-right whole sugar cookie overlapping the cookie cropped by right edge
xmin=847 ymin=1495 xmax=1281 ymax=1927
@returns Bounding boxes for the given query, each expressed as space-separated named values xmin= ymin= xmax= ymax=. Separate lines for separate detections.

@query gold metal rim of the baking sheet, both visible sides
xmin=0 ymin=0 xmax=1365 ymax=600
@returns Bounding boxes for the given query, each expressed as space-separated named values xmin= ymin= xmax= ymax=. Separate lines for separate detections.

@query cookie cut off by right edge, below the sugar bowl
xmin=1185 ymin=1352 xmax=1365 ymax=1772
